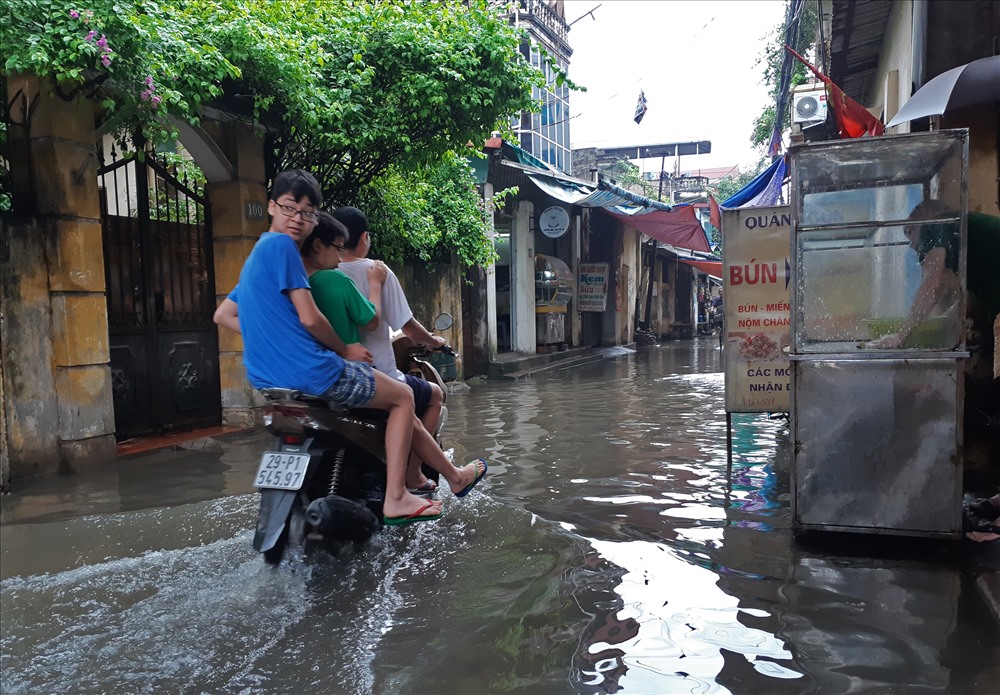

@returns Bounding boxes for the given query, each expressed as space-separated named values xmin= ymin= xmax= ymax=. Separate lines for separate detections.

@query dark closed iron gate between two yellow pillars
xmin=98 ymin=146 xmax=221 ymax=440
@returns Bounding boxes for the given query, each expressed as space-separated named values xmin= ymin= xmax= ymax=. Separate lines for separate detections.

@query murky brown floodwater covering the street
xmin=0 ymin=339 xmax=1000 ymax=695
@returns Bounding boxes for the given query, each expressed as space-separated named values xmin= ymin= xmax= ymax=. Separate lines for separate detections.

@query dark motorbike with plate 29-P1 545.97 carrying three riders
xmin=253 ymin=314 xmax=455 ymax=565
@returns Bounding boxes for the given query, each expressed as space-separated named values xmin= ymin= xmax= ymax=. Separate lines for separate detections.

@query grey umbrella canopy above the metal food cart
xmin=885 ymin=56 xmax=1000 ymax=128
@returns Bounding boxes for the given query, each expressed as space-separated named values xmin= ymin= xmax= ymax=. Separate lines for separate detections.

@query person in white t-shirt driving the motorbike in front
xmin=333 ymin=206 xmax=447 ymax=492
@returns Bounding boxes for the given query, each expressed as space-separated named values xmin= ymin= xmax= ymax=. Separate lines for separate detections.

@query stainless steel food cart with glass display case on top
xmin=790 ymin=130 xmax=968 ymax=537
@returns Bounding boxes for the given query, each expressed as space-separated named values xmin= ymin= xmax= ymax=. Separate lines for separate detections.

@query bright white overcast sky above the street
xmin=566 ymin=0 xmax=785 ymax=177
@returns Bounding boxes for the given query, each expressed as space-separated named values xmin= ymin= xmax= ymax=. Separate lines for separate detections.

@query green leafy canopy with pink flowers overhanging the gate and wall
xmin=0 ymin=0 xmax=543 ymax=263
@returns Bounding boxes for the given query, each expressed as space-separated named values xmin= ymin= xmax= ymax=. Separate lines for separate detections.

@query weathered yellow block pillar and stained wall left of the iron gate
xmin=0 ymin=75 xmax=115 ymax=483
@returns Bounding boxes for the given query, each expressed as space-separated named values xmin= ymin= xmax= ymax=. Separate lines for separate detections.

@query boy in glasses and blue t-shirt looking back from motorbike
xmin=215 ymin=170 xmax=486 ymax=524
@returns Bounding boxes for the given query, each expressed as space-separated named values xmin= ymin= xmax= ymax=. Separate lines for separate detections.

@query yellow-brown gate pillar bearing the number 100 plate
xmin=205 ymin=123 xmax=268 ymax=426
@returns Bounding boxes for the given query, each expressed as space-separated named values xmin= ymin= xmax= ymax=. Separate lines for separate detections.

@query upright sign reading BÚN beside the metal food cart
xmin=722 ymin=206 xmax=792 ymax=413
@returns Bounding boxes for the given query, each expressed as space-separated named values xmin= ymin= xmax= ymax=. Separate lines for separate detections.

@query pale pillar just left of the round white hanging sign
xmin=510 ymin=200 xmax=536 ymax=355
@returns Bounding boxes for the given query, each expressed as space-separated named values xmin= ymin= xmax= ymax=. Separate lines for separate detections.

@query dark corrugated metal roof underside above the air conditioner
xmin=830 ymin=0 xmax=893 ymax=106
